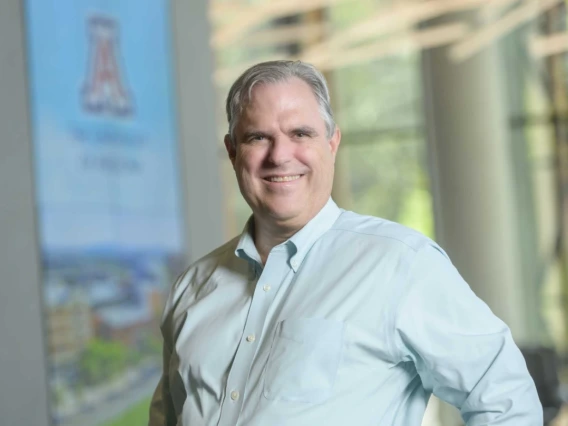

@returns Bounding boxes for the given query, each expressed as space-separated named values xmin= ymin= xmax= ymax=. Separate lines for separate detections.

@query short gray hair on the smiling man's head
xmin=225 ymin=60 xmax=335 ymax=146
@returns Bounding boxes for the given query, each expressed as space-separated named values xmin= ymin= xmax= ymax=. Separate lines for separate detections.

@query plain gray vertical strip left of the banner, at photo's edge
xmin=0 ymin=0 xmax=49 ymax=426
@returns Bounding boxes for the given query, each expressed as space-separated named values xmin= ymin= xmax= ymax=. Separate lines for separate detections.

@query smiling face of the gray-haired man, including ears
xmin=225 ymin=78 xmax=341 ymax=228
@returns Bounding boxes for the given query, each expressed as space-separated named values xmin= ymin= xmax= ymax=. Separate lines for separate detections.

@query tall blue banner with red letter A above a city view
xmin=27 ymin=0 xmax=187 ymax=426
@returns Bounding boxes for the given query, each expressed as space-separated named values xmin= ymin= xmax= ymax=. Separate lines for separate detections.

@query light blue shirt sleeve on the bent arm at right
xmin=394 ymin=245 xmax=543 ymax=426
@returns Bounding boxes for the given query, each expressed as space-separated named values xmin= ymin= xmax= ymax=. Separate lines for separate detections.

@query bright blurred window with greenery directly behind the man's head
xmin=210 ymin=0 xmax=434 ymax=238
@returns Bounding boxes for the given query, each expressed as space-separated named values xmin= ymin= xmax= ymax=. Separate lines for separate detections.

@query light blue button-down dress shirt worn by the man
xmin=150 ymin=199 xmax=543 ymax=426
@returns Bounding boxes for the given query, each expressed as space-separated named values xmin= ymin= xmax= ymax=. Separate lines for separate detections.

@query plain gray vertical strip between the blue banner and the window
xmin=172 ymin=0 xmax=226 ymax=260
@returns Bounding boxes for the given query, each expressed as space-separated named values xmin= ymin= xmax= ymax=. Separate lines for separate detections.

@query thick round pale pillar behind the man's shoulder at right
xmin=422 ymin=15 xmax=530 ymax=426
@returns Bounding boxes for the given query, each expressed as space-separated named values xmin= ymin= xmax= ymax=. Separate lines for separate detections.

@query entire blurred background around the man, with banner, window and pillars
xmin=0 ymin=0 xmax=568 ymax=426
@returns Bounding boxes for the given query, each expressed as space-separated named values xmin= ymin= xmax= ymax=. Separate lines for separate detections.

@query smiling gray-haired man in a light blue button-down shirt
xmin=150 ymin=61 xmax=542 ymax=426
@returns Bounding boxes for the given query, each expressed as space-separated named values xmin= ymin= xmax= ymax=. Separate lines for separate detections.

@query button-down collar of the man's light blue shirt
xmin=235 ymin=197 xmax=342 ymax=272
